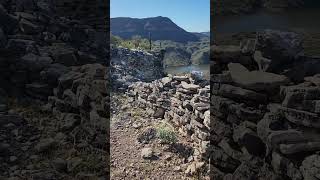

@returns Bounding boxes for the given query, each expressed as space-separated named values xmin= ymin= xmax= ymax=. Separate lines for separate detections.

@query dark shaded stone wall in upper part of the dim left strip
xmin=0 ymin=0 xmax=109 ymax=100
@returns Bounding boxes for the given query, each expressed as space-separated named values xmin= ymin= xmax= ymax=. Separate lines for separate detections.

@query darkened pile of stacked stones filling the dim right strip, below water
xmin=210 ymin=30 xmax=320 ymax=180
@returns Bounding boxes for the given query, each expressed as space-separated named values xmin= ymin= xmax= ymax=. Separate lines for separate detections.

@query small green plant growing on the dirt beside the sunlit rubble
xmin=157 ymin=124 xmax=177 ymax=144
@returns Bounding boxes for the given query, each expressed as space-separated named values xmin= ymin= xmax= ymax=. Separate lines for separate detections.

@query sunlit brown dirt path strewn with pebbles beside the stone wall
xmin=110 ymin=95 xmax=201 ymax=180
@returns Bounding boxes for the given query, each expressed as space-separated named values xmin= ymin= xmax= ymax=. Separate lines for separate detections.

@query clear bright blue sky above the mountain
xmin=110 ymin=0 xmax=210 ymax=32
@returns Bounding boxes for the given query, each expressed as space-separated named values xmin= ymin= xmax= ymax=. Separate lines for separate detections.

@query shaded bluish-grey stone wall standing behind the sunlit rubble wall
xmin=110 ymin=48 xmax=164 ymax=89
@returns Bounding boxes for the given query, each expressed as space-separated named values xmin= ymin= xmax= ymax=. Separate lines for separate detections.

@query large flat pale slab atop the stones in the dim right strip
xmin=228 ymin=63 xmax=289 ymax=92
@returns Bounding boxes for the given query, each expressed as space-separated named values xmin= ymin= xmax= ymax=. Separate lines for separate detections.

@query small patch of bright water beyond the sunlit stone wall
xmin=165 ymin=64 xmax=210 ymax=76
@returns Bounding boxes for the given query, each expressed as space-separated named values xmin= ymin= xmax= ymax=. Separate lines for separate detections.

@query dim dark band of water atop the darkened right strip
xmin=213 ymin=8 xmax=320 ymax=33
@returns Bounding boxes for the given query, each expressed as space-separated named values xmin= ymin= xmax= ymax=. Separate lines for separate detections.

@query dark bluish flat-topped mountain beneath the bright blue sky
xmin=110 ymin=16 xmax=199 ymax=43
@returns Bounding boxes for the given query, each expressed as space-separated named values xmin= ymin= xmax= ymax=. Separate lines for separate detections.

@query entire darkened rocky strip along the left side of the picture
xmin=0 ymin=0 xmax=109 ymax=179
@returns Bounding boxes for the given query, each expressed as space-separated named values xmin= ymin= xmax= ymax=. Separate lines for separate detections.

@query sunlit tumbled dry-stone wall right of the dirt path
xmin=127 ymin=76 xmax=211 ymax=174
